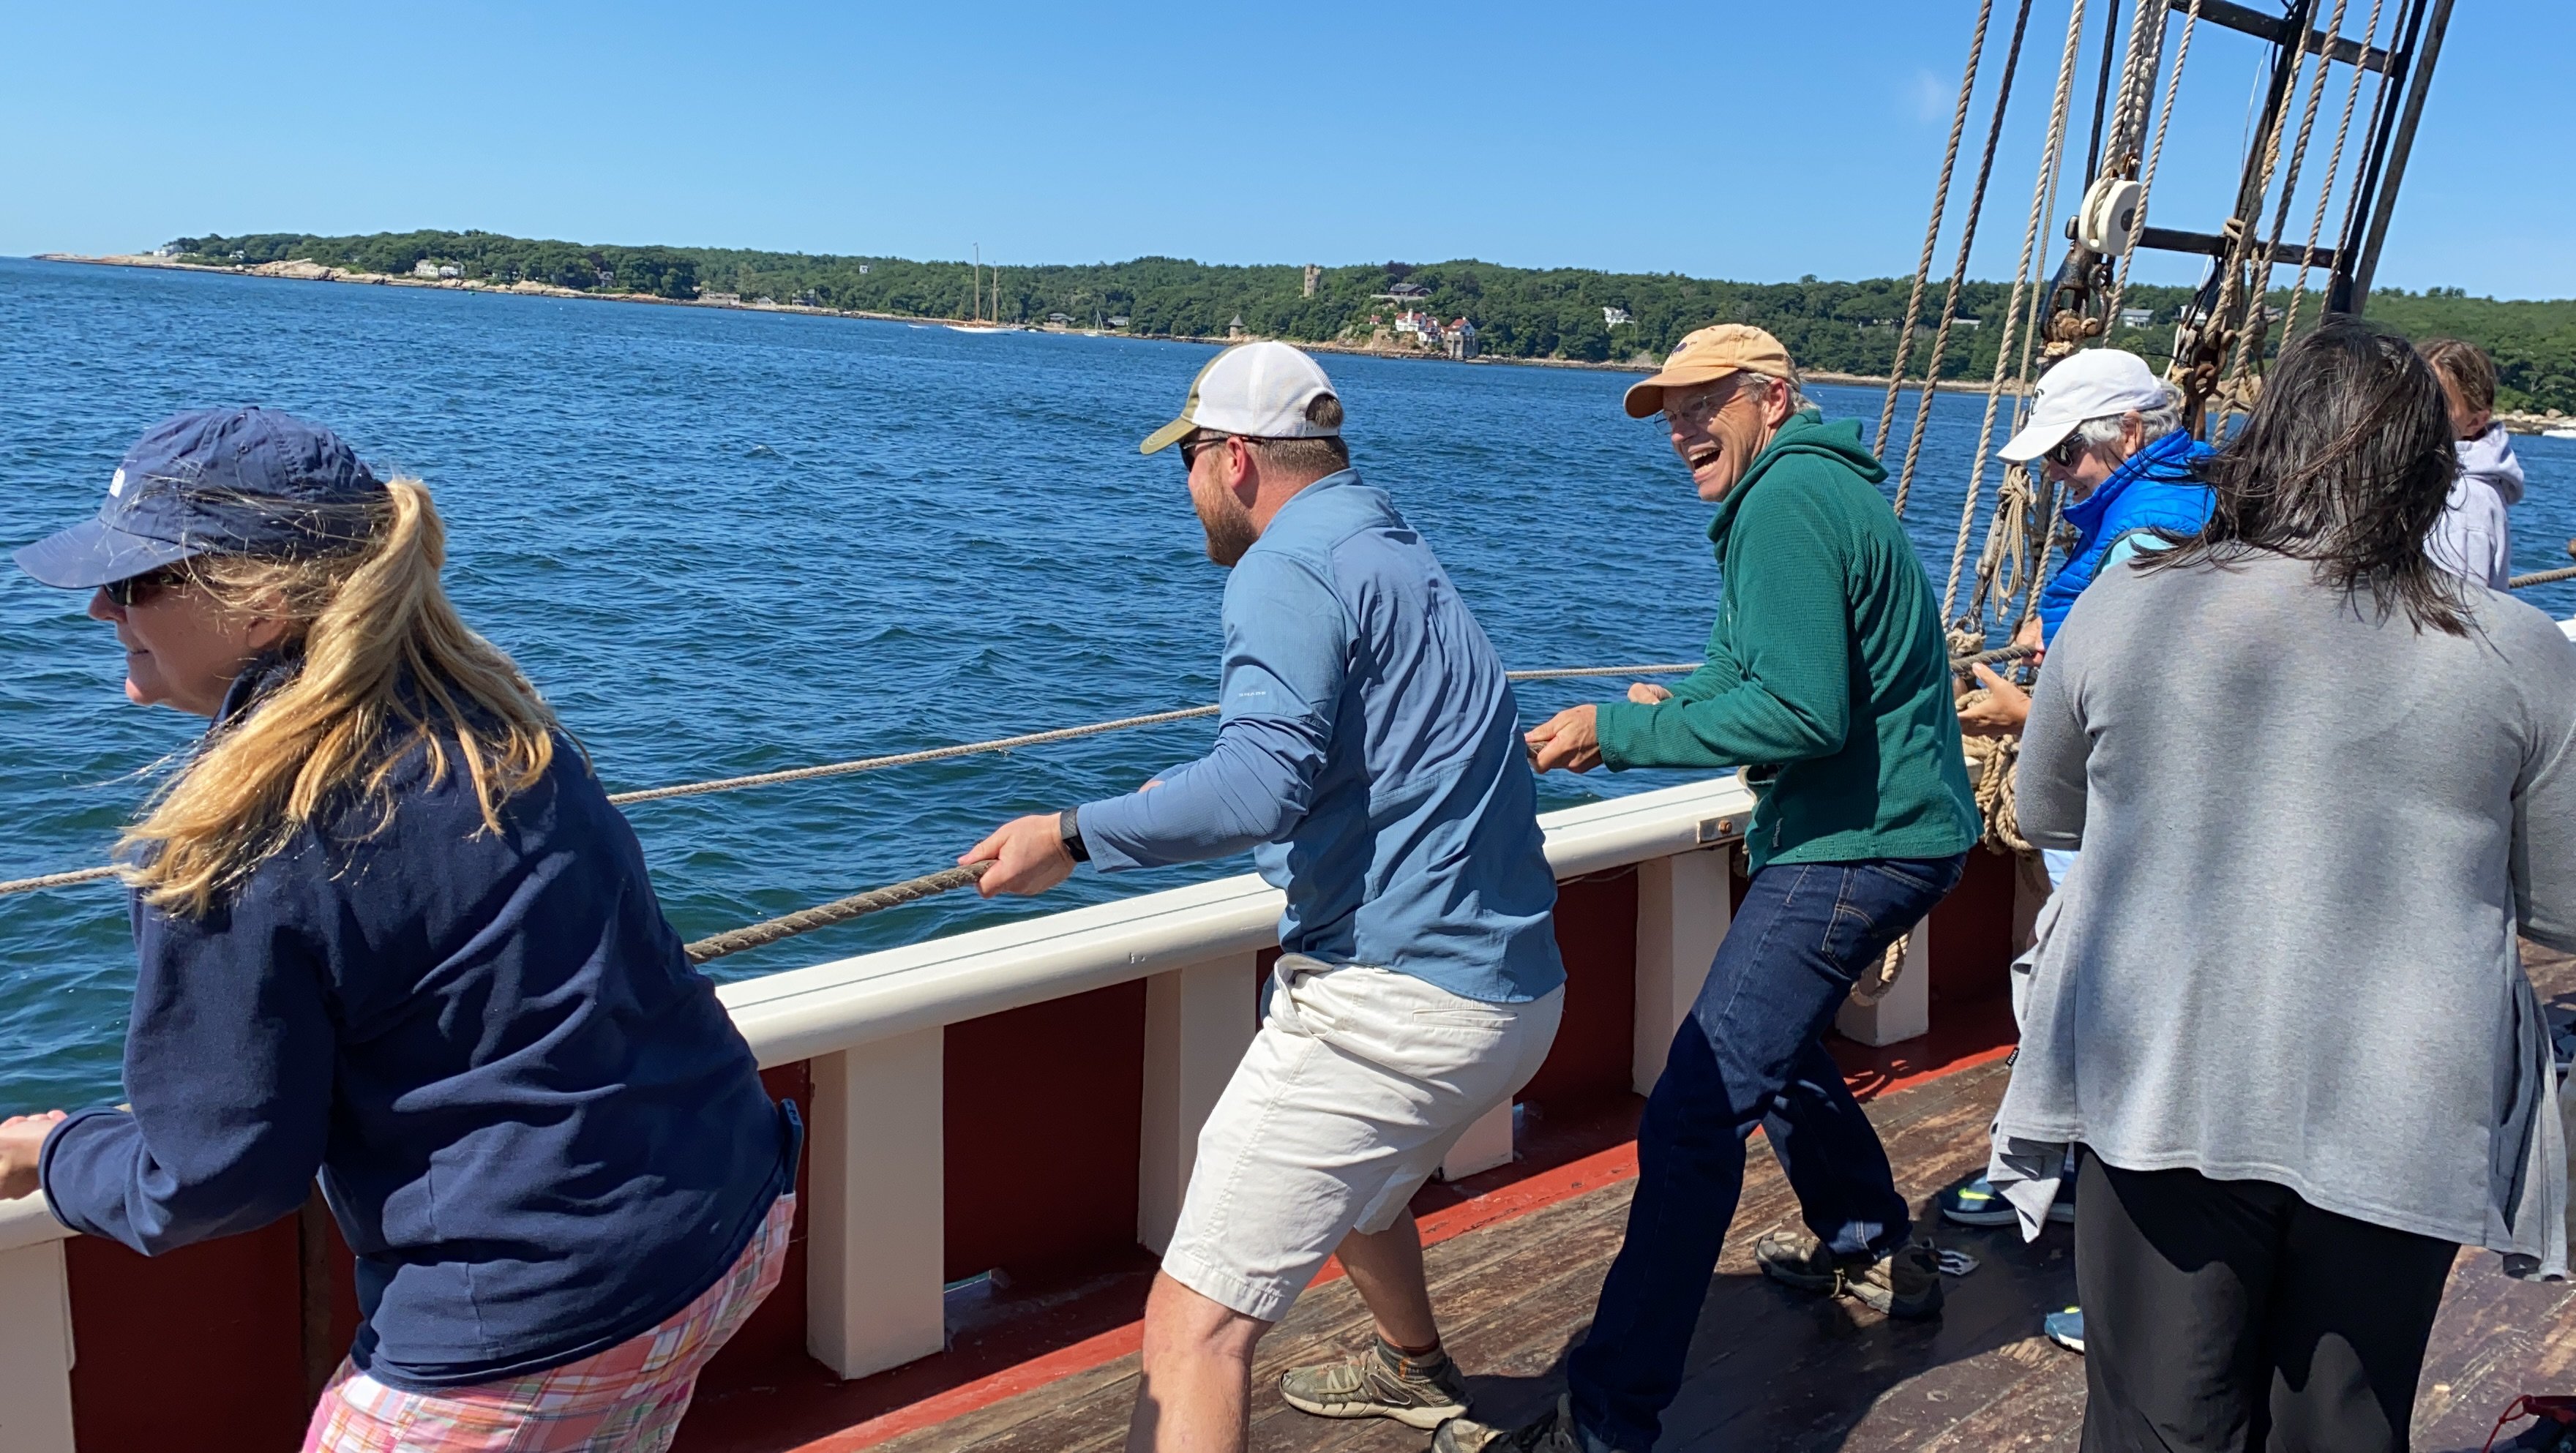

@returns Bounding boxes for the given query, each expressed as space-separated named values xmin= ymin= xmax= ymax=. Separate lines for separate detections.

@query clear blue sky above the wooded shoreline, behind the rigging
xmin=0 ymin=0 xmax=2576 ymax=296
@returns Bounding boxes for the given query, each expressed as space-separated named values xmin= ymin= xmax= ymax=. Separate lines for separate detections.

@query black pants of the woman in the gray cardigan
xmin=2076 ymin=1154 xmax=2457 ymax=1453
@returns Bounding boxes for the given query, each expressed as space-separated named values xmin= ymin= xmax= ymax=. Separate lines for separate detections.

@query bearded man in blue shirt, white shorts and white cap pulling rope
xmin=958 ymin=342 xmax=1566 ymax=1453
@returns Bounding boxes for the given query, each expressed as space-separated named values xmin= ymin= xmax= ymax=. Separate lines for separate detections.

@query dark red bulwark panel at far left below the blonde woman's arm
xmin=61 ymin=1216 xmax=309 ymax=1453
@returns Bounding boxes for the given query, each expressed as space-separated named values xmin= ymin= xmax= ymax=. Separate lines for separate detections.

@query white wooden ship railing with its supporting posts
xmin=0 ymin=776 xmax=1834 ymax=1453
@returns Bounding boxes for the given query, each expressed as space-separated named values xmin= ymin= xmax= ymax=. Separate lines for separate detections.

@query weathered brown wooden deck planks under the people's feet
xmin=881 ymin=948 xmax=2576 ymax=1453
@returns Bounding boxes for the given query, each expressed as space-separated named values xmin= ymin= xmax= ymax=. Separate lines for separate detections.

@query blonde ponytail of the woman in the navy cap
xmin=119 ymin=479 xmax=559 ymax=917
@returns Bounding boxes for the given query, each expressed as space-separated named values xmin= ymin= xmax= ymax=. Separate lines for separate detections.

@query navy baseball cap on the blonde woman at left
xmin=13 ymin=407 xmax=383 ymax=590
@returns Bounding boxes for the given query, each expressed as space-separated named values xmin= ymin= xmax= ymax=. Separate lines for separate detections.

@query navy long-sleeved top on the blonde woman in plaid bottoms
xmin=41 ymin=662 xmax=798 ymax=1389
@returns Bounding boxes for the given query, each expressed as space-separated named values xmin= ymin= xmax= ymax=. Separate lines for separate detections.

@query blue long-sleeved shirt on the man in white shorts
xmin=1079 ymin=469 xmax=1566 ymax=1002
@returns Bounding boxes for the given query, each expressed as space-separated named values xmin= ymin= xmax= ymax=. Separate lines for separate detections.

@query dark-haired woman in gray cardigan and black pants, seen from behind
xmin=1988 ymin=322 xmax=2576 ymax=1453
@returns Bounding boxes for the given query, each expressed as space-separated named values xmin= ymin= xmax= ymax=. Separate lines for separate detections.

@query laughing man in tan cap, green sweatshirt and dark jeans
xmin=1435 ymin=325 xmax=1978 ymax=1453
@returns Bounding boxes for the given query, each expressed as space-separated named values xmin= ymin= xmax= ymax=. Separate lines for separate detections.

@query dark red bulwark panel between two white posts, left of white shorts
xmin=943 ymin=979 xmax=1146 ymax=1280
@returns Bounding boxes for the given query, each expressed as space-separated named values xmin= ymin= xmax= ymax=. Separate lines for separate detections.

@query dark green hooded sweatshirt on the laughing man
xmin=1600 ymin=410 xmax=1981 ymax=868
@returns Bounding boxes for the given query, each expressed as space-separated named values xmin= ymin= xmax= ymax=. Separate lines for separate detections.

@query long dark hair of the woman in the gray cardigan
xmin=2138 ymin=320 xmax=2468 ymax=637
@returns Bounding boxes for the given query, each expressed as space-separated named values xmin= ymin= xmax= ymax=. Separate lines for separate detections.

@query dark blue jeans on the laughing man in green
xmin=1569 ymin=855 xmax=1968 ymax=1453
